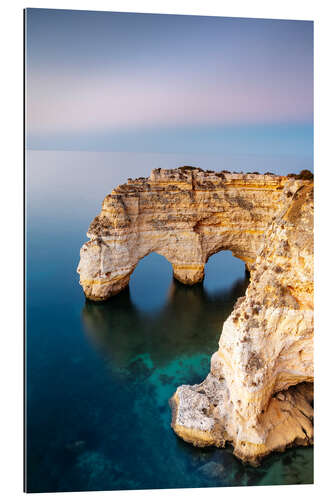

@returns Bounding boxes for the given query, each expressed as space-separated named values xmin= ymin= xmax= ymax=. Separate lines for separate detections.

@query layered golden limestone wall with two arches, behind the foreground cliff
xmin=78 ymin=169 xmax=293 ymax=300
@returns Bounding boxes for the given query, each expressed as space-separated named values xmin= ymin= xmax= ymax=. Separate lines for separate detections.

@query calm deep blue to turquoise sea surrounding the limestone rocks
xmin=26 ymin=152 xmax=313 ymax=492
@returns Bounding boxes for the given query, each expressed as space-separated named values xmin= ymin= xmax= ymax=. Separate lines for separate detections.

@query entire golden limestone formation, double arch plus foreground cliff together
xmin=78 ymin=167 xmax=313 ymax=464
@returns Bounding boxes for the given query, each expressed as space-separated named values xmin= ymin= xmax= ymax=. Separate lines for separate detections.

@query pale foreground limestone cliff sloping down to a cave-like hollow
xmin=171 ymin=181 xmax=313 ymax=465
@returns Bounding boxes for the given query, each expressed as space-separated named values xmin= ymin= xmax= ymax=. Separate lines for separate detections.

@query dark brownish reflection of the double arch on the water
xmin=82 ymin=274 xmax=248 ymax=381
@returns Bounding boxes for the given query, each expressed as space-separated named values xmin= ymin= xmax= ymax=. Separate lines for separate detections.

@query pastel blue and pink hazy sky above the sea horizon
xmin=26 ymin=9 xmax=313 ymax=160
